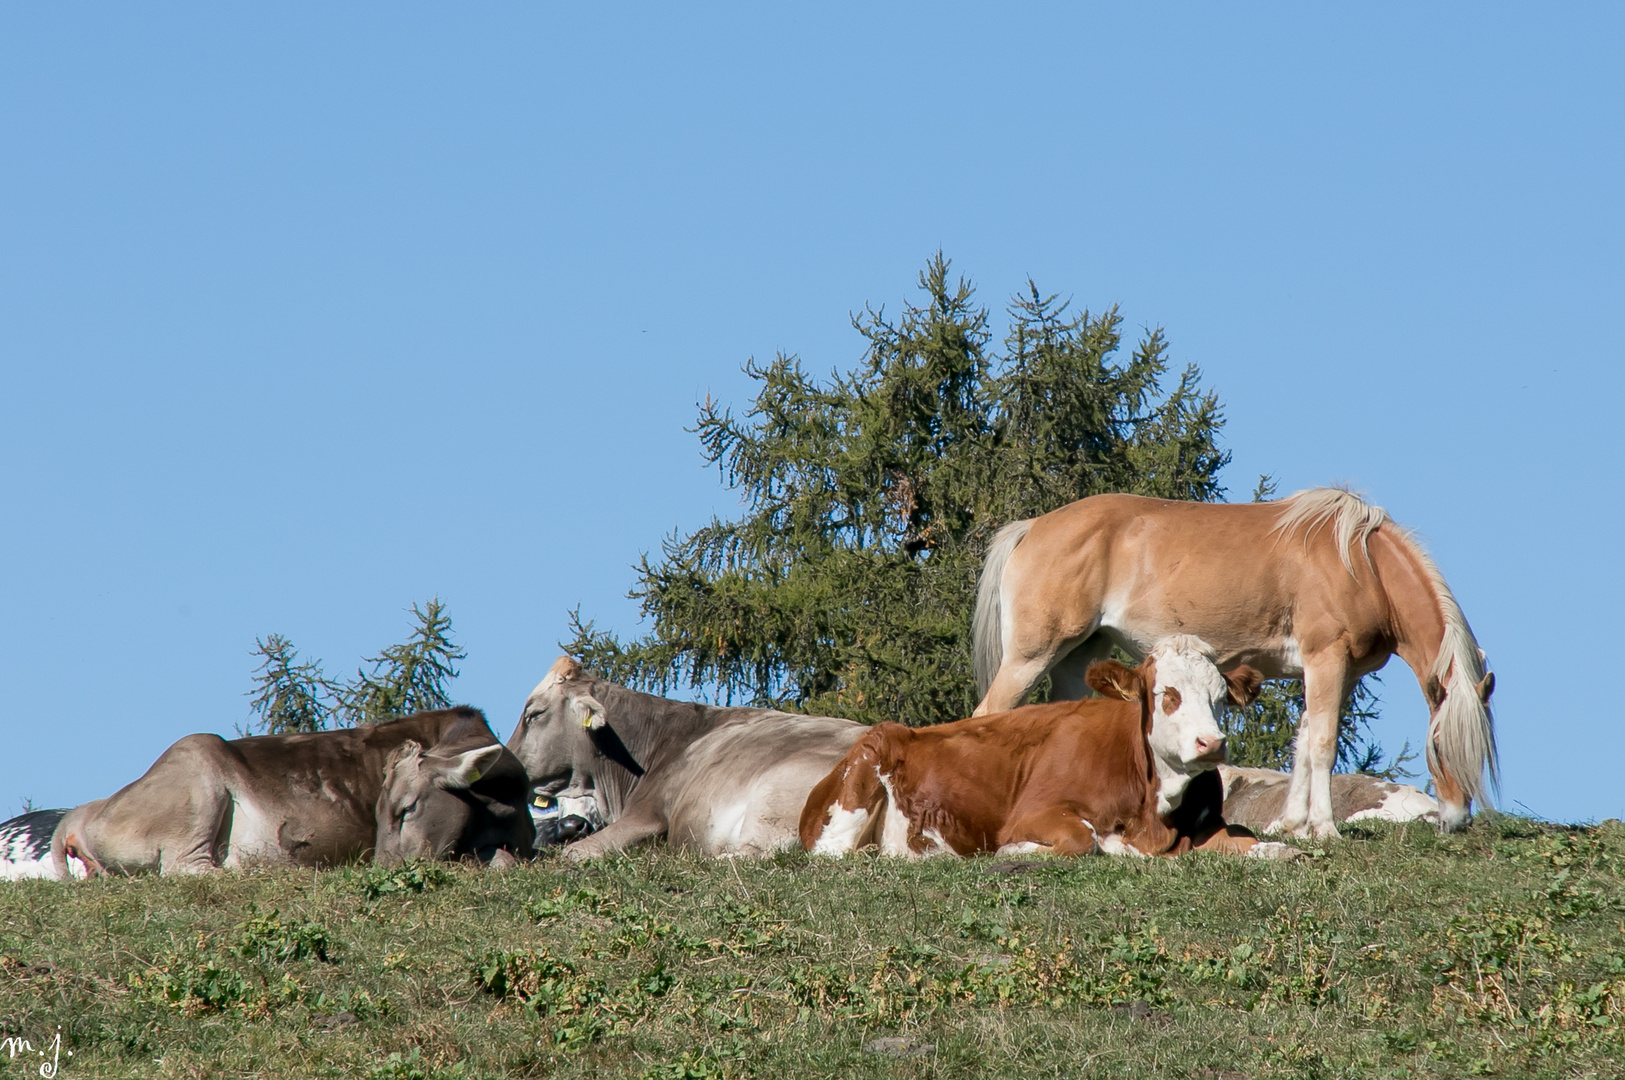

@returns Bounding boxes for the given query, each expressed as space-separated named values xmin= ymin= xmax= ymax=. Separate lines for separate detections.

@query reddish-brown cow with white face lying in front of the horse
xmin=801 ymin=635 xmax=1290 ymax=856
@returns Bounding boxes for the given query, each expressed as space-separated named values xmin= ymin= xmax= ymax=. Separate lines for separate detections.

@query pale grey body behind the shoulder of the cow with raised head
xmin=660 ymin=711 xmax=868 ymax=854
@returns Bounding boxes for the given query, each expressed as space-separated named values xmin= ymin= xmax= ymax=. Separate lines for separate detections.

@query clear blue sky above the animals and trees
xmin=0 ymin=3 xmax=1625 ymax=819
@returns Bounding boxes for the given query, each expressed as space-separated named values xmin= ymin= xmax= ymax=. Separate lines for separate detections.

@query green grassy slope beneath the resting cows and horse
xmin=0 ymin=817 xmax=1625 ymax=1080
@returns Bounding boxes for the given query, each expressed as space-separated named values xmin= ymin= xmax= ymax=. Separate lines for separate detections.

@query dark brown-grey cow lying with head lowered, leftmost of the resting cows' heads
xmin=52 ymin=706 xmax=533 ymax=879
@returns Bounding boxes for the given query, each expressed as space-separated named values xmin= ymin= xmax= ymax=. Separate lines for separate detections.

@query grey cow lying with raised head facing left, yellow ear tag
xmin=509 ymin=656 xmax=866 ymax=859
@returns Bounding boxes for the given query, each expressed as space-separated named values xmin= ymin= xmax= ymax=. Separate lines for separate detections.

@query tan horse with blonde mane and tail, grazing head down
xmin=973 ymin=487 xmax=1497 ymax=836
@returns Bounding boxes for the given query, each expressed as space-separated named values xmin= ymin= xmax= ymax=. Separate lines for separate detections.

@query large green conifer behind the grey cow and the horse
xmin=566 ymin=255 xmax=1229 ymax=724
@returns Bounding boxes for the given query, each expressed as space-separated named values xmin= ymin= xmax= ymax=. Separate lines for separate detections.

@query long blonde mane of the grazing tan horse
xmin=1271 ymin=487 xmax=1500 ymax=801
